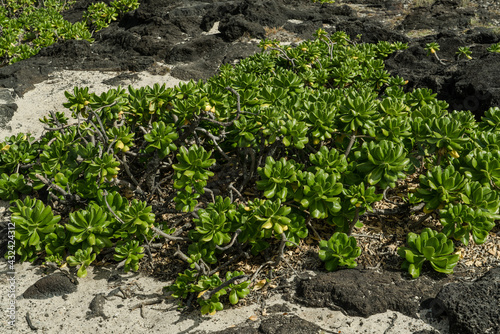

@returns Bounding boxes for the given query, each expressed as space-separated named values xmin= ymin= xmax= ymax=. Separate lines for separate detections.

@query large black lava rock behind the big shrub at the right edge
xmin=385 ymin=28 xmax=500 ymax=120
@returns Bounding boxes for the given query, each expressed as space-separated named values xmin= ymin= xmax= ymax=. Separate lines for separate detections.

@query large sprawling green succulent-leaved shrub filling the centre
xmin=0 ymin=30 xmax=500 ymax=314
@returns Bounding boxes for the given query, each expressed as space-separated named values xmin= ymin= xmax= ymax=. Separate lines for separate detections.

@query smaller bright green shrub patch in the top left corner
xmin=0 ymin=0 xmax=139 ymax=66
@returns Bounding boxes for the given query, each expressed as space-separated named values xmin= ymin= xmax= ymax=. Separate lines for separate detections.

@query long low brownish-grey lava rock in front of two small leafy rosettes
xmin=297 ymin=269 xmax=448 ymax=317
